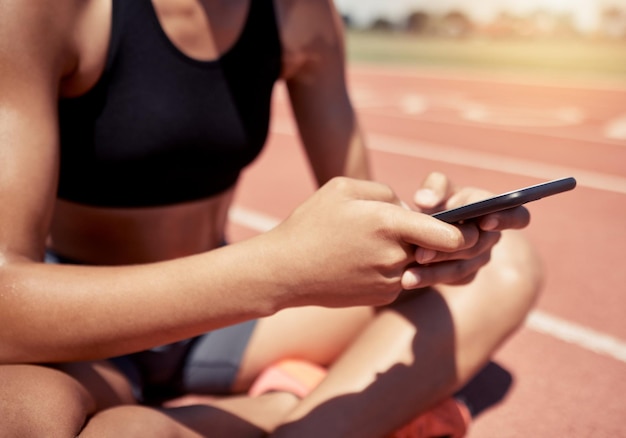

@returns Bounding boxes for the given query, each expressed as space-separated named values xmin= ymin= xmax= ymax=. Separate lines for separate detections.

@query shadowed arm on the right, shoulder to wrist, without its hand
xmin=279 ymin=0 xmax=370 ymax=185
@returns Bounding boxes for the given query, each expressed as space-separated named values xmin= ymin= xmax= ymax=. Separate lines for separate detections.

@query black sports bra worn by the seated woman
xmin=58 ymin=0 xmax=281 ymax=207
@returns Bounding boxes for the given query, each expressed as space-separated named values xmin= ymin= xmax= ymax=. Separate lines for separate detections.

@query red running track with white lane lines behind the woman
xmin=230 ymin=66 xmax=626 ymax=438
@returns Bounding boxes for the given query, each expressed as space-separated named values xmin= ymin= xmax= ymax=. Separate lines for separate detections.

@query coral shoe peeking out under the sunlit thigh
xmin=248 ymin=359 xmax=326 ymax=398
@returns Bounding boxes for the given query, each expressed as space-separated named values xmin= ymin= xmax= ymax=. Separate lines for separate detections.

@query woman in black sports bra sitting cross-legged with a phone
xmin=0 ymin=0 xmax=540 ymax=437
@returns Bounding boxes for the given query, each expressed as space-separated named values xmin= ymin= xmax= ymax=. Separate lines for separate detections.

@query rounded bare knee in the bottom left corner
xmin=0 ymin=365 xmax=91 ymax=438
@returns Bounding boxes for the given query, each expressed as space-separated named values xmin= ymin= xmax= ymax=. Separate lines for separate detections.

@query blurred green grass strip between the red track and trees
xmin=346 ymin=31 xmax=626 ymax=86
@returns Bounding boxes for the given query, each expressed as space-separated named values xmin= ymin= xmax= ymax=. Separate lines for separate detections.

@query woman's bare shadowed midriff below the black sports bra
xmin=49 ymin=188 xmax=234 ymax=265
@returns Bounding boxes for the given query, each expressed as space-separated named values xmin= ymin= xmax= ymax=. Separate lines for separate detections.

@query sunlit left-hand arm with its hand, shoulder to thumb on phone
xmin=0 ymin=0 xmax=510 ymax=363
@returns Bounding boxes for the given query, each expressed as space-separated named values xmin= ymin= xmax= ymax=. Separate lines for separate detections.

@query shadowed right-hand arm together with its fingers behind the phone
xmin=278 ymin=0 xmax=529 ymax=289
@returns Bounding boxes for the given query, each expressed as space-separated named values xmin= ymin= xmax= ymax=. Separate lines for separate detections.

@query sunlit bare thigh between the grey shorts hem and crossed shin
xmin=233 ymin=307 xmax=375 ymax=392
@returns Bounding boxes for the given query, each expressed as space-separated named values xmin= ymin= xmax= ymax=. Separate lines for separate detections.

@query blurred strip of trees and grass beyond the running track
xmin=335 ymin=0 xmax=626 ymax=82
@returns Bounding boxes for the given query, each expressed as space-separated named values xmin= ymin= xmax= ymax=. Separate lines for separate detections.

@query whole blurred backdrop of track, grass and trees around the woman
xmin=229 ymin=0 xmax=626 ymax=438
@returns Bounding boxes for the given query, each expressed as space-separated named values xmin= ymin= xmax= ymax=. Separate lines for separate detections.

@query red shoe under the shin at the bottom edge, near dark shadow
xmin=388 ymin=398 xmax=472 ymax=438
